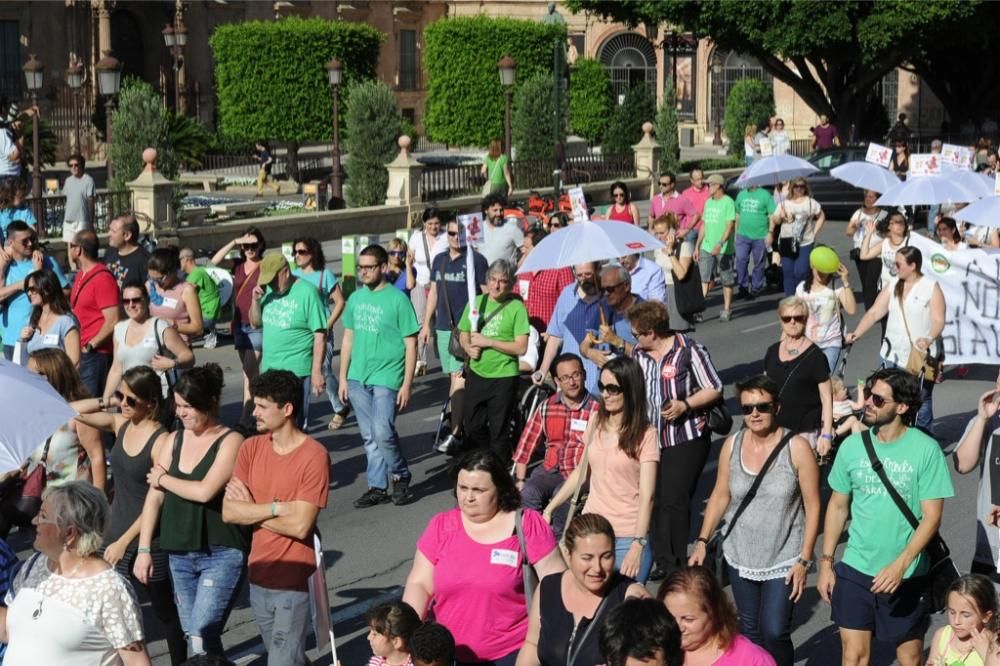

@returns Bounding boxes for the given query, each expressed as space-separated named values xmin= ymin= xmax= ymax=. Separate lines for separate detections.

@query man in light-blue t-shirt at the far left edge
xmin=0 ymin=220 xmax=69 ymax=361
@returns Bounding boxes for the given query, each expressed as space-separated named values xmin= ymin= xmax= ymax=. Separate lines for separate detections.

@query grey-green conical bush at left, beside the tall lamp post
xmin=108 ymin=77 xmax=178 ymax=190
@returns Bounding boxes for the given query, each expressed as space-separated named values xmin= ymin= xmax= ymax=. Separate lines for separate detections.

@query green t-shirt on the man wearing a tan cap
xmin=260 ymin=280 xmax=326 ymax=377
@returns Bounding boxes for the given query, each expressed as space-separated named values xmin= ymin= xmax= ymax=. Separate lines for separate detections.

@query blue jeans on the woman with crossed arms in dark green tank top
xmin=170 ymin=546 xmax=246 ymax=657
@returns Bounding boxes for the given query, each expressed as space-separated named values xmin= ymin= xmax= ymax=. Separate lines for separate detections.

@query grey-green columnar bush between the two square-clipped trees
xmin=344 ymin=81 xmax=401 ymax=206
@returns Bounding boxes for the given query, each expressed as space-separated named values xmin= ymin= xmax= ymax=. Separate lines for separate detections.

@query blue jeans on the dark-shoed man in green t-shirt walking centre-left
xmin=347 ymin=379 xmax=410 ymax=490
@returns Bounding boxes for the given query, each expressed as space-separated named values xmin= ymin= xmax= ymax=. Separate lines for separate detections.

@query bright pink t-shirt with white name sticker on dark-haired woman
xmin=417 ymin=508 xmax=556 ymax=662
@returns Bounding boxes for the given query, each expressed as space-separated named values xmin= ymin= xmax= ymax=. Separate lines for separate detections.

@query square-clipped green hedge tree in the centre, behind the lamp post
xmin=424 ymin=15 xmax=566 ymax=147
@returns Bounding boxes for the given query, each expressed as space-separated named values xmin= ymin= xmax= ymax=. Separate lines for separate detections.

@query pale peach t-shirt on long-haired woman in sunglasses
xmin=583 ymin=427 xmax=660 ymax=539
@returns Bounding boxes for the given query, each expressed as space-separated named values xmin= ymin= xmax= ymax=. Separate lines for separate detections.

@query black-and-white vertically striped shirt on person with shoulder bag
xmin=633 ymin=333 xmax=722 ymax=448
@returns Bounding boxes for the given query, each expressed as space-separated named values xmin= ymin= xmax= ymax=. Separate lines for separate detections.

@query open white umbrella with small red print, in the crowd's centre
xmin=517 ymin=221 xmax=663 ymax=273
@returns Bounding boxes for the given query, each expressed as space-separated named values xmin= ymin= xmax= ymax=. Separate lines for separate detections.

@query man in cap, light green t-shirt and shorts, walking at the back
xmin=694 ymin=174 xmax=736 ymax=321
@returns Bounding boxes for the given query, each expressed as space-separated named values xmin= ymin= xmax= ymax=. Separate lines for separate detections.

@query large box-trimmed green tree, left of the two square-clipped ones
xmin=209 ymin=17 xmax=385 ymax=187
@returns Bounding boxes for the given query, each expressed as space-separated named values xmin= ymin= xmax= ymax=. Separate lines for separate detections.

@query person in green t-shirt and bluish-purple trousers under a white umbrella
xmin=736 ymin=185 xmax=775 ymax=300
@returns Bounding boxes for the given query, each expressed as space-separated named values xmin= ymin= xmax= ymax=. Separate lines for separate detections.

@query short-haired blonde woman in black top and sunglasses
xmin=764 ymin=296 xmax=833 ymax=456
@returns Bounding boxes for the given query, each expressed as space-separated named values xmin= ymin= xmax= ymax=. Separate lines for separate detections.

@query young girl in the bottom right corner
xmin=927 ymin=574 xmax=1000 ymax=666
